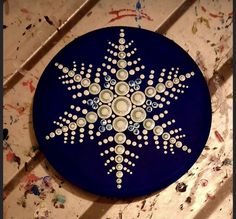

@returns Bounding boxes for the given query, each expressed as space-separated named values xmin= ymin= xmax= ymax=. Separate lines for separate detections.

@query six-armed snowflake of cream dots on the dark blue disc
xmin=46 ymin=29 xmax=194 ymax=189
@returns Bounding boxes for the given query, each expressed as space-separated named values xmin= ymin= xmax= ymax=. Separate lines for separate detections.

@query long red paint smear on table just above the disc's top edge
xmin=108 ymin=9 xmax=153 ymax=23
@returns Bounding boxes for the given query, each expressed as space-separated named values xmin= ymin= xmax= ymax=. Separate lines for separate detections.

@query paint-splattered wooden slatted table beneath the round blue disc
xmin=3 ymin=0 xmax=233 ymax=219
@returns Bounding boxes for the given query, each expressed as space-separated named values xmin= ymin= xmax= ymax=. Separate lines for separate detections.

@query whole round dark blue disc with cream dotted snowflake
xmin=33 ymin=27 xmax=211 ymax=197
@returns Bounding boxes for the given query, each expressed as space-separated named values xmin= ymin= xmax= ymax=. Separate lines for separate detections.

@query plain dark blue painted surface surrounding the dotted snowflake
xmin=33 ymin=27 xmax=211 ymax=197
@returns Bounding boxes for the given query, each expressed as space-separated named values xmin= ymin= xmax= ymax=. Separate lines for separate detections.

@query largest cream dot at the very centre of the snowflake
xmin=111 ymin=96 xmax=132 ymax=116
